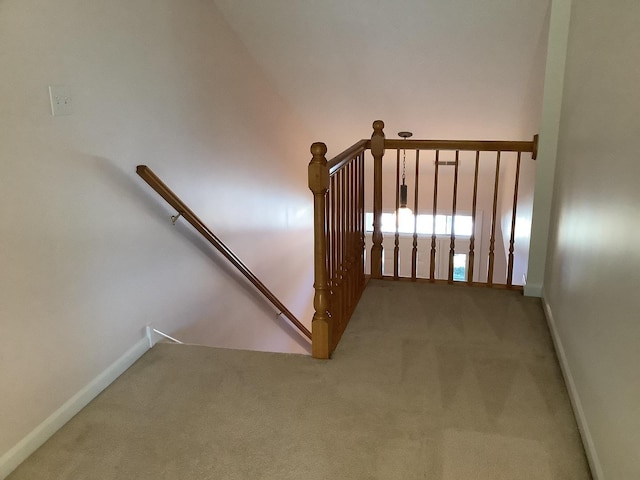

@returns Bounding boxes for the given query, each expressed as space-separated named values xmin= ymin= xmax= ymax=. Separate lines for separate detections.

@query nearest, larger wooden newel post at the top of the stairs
xmin=309 ymin=143 xmax=332 ymax=358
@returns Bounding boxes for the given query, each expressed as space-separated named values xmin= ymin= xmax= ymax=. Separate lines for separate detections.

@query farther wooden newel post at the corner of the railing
xmin=371 ymin=120 xmax=384 ymax=278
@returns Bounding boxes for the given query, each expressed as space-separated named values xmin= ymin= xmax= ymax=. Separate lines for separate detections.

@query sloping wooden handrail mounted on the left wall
xmin=136 ymin=165 xmax=311 ymax=340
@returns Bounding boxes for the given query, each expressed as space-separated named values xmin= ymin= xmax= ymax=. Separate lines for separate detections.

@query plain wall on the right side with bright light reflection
xmin=544 ymin=0 xmax=640 ymax=480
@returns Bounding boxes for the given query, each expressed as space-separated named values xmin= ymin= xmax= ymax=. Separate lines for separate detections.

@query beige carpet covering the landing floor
xmin=9 ymin=281 xmax=591 ymax=480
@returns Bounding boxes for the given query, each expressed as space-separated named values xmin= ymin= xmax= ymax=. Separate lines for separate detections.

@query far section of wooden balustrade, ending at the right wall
xmin=371 ymin=122 xmax=537 ymax=288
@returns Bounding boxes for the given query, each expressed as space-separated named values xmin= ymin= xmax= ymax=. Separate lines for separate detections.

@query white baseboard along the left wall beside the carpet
xmin=0 ymin=338 xmax=150 ymax=480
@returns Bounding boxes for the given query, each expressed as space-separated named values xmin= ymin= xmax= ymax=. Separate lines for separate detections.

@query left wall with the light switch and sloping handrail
xmin=0 ymin=0 xmax=312 ymax=464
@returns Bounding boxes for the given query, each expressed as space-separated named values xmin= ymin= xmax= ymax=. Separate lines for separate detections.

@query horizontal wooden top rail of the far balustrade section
xmin=384 ymin=138 xmax=536 ymax=158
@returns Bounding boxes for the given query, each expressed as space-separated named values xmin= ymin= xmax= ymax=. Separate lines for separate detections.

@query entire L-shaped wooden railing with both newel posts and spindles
xmin=309 ymin=120 xmax=537 ymax=358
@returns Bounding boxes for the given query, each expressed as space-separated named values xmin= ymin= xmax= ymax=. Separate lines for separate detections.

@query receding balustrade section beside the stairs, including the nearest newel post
xmin=309 ymin=140 xmax=369 ymax=358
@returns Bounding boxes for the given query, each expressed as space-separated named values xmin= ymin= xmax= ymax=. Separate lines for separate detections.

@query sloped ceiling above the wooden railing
xmin=215 ymin=0 xmax=550 ymax=154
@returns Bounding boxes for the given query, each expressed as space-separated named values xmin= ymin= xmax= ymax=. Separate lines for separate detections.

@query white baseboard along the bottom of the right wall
xmin=542 ymin=292 xmax=604 ymax=480
